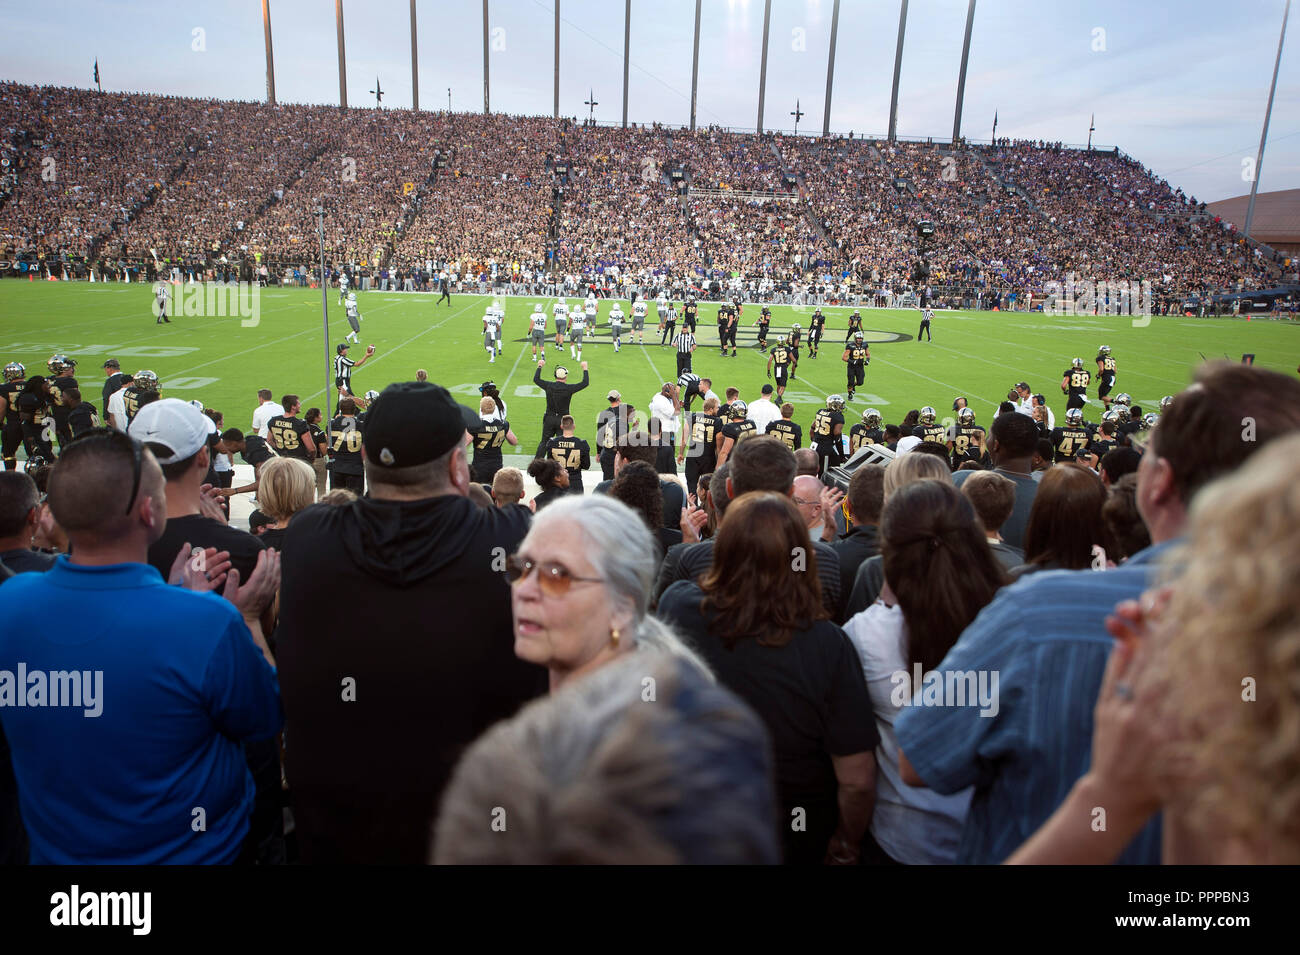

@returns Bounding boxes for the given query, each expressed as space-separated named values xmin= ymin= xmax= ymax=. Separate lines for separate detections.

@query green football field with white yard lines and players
xmin=0 ymin=281 xmax=1300 ymax=453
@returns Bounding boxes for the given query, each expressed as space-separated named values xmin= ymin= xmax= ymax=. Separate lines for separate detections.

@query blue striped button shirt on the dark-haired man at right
xmin=894 ymin=541 xmax=1177 ymax=865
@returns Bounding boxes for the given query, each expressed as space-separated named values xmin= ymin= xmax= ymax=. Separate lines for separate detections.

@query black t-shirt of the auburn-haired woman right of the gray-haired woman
xmin=655 ymin=581 xmax=880 ymax=861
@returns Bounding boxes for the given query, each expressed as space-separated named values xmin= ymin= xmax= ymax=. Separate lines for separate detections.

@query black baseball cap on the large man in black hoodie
xmin=363 ymin=381 xmax=481 ymax=468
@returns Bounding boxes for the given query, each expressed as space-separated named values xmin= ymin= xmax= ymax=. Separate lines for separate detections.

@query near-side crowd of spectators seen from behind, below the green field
xmin=0 ymin=350 xmax=1300 ymax=865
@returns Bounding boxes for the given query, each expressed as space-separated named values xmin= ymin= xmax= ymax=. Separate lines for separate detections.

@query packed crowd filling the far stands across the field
xmin=0 ymin=83 xmax=1295 ymax=304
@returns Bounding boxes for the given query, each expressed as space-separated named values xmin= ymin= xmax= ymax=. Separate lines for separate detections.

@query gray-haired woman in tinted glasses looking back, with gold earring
xmin=506 ymin=495 xmax=710 ymax=693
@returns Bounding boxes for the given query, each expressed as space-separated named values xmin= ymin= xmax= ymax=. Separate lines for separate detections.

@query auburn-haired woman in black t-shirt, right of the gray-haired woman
xmin=658 ymin=491 xmax=880 ymax=865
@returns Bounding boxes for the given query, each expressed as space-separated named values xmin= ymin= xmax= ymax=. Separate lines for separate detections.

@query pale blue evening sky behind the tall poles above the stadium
xmin=0 ymin=0 xmax=1300 ymax=201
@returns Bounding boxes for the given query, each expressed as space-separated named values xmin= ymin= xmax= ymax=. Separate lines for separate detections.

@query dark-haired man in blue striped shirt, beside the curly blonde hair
xmin=896 ymin=363 xmax=1300 ymax=864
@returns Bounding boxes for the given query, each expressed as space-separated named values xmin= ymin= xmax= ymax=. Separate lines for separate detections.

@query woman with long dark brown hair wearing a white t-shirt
xmin=844 ymin=481 xmax=1006 ymax=865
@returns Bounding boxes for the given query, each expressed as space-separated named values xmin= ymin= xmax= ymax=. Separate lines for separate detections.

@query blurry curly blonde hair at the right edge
xmin=1161 ymin=435 xmax=1300 ymax=864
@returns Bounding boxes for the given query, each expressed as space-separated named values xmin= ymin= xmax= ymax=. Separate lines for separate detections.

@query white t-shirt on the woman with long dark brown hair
xmin=844 ymin=600 xmax=975 ymax=865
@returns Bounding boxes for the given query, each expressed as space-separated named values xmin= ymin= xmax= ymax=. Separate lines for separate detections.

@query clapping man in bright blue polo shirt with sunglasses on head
xmin=0 ymin=433 xmax=281 ymax=865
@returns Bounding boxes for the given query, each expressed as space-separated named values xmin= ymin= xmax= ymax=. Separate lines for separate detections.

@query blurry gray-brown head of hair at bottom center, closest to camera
xmin=432 ymin=654 xmax=780 ymax=865
